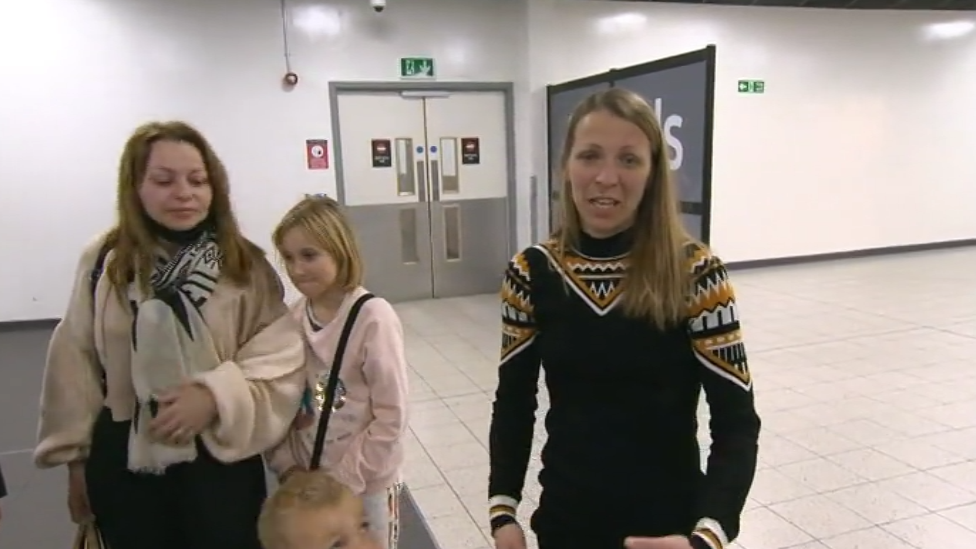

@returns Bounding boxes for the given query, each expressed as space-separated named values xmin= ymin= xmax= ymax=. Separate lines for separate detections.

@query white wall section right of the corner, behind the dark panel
xmin=530 ymin=0 xmax=976 ymax=260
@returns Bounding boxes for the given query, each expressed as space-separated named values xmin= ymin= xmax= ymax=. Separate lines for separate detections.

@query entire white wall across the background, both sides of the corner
xmin=0 ymin=0 xmax=976 ymax=321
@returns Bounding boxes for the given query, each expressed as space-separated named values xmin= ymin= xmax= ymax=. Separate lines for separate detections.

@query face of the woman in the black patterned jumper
xmin=566 ymin=111 xmax=653 ymax=238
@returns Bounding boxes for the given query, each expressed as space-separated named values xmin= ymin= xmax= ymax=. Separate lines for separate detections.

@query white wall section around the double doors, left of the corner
xmin=0 ymin=0 xmax=529 ymax=322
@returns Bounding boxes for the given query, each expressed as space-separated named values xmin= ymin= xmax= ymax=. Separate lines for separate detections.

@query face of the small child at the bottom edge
xmin=288 ymin=495 xmax=380 ymax=549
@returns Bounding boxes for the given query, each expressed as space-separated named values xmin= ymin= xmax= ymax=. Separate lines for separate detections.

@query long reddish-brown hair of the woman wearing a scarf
xmin=105 ymin=121 xmax=264 ymax=289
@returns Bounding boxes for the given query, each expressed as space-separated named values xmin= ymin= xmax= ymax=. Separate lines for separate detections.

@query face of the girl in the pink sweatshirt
xmin=278 ymin=228 xmax=339 ymax=299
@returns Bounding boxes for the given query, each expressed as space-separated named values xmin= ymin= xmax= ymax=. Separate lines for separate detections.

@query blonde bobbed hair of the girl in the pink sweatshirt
xmin=271 ymin=194 xmax=363 ymax=291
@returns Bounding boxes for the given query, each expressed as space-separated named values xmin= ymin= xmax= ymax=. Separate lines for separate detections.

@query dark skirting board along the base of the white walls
xmin=0 ymin=238 xmax=976 ymax=332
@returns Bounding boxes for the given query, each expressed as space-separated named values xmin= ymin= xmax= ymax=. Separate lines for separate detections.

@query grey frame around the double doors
xmin=329 ymin=81 xmax=518 ymax=260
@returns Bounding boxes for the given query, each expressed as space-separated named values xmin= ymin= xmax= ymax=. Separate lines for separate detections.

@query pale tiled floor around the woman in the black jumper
xmin=398 ymin=250 xmax=976 ymax=549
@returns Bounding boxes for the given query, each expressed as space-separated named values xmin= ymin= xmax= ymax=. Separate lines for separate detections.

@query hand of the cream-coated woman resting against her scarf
xmin=149 ymin=382 xmax=217 ymax=446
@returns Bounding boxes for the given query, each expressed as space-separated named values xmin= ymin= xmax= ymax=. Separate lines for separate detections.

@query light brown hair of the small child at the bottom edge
xmin=258 ymin=470 xmax=352 ymax=549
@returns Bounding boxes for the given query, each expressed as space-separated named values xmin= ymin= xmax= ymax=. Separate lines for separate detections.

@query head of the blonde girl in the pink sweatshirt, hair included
xmin=271 ymin=195 xmax=363 ymax=299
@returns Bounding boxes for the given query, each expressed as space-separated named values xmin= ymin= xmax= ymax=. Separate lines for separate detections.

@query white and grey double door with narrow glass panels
xmin=336 ymin=92 xmax=511 ymax=301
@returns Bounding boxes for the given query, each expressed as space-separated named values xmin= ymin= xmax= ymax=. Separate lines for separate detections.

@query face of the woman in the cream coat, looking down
xmin=139 ymin=141 xmax=213 ymax=231
